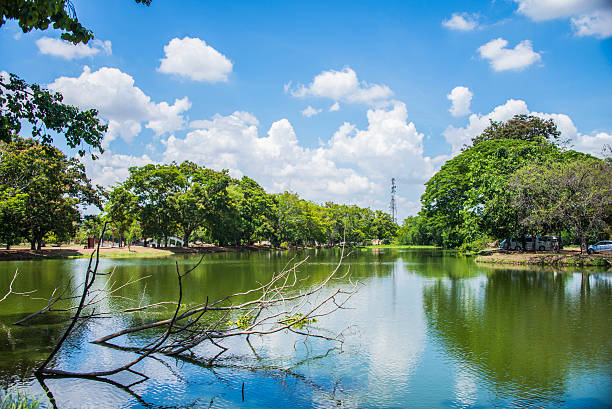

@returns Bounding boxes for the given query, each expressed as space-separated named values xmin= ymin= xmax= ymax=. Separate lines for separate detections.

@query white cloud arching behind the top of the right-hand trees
xmin=442 ymin=99 xmax=612 ymax=156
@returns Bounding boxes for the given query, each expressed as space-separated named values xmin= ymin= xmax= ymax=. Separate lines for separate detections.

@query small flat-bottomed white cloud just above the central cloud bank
xmin=285 ymin=67 xmax=393 ymax=104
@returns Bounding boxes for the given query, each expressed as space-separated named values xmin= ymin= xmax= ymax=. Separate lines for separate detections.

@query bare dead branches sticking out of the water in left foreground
xmin=18 ymin=225 xmax=357 ymax=392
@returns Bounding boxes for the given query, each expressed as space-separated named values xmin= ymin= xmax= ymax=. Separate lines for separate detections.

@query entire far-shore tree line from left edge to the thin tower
xmin=0 ymin=137 xmax=399 ymax=249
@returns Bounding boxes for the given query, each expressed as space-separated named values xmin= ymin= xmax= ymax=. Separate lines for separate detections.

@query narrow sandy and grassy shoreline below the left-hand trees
xmin=0 ymin=245 xmax=271 ymax=262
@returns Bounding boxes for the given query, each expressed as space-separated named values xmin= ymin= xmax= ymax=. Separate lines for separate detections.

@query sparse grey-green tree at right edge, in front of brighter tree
xmin=510 ymin=155 xmax=612 ymax=252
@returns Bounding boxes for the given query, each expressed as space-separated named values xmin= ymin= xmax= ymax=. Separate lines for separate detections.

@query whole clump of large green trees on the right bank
xmin=398 ymin=115 xmax=612 ymax=250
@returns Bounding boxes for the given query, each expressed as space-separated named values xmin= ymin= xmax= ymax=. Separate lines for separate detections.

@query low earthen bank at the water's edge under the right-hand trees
xmin=475 ymin=249 xmax=612 ymax=267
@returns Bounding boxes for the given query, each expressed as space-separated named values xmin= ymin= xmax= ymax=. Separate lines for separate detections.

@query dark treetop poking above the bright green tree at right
xmin=472 ymin=115 xmax=561 ymax=146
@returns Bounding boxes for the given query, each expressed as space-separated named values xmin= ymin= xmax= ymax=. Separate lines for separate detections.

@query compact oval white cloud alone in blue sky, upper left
xmin=157 ymin=37 xmax=233 ymax=82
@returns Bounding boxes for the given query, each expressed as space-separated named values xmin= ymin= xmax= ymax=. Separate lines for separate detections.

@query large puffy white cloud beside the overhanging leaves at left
xmin=48 ymin=66 xmax=191 ymax=146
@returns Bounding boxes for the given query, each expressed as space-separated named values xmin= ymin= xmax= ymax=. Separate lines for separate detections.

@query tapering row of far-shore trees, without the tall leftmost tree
xmin=106 ymin=162 xmax=398 ymax=246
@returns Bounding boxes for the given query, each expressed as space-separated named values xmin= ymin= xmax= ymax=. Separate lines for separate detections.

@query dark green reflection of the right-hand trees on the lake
xmin=423 ymin=270 xmax=612 ymax=405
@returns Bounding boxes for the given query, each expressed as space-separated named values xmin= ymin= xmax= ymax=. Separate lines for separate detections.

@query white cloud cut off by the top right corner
xmin=514 ymin=0 xmax=612 ymax=39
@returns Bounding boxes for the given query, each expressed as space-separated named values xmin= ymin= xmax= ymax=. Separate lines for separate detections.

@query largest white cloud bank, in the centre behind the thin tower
xmin=162 ymin=102 xmax=442 ymax=217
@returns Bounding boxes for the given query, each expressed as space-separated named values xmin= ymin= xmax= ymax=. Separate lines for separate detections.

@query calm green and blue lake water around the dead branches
xmin=0 ymin=248 xmax=612 ymax=408
